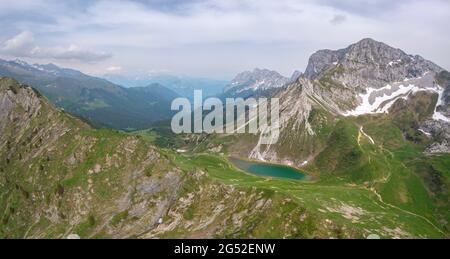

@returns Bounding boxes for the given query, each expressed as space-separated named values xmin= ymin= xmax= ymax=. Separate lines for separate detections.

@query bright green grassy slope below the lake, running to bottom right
xmin=167 ymin=154 xmax=445 ymax=238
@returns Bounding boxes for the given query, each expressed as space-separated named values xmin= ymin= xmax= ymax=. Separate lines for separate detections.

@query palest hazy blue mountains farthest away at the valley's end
xmin=103 ymin=74 xmax=228 ymax=99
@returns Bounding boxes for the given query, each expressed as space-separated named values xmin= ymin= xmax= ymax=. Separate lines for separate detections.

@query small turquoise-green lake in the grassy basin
xmin=229 ymin=158 xmax=306 ymax=180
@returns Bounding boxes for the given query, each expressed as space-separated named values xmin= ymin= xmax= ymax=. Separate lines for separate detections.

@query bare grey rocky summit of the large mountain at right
xmin=305 ymin=39 xmax=443 ymax=91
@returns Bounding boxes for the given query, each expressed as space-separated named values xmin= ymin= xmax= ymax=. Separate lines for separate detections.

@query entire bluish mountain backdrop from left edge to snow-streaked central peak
xmin=0 ymin=59 xmax=302 ymax=130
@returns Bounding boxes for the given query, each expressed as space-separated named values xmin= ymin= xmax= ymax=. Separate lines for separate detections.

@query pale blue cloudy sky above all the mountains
xmin=0 ymin=0 xmax=450 ymax=79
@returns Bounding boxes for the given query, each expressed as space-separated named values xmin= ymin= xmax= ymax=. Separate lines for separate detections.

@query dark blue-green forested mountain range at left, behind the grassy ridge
xmin=0 ymin=60 xmax=179 ymax=129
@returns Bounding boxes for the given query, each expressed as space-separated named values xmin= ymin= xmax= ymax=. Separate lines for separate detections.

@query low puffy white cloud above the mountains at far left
xmin=0 ymin=31 xmax=112 ymax=62
